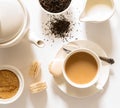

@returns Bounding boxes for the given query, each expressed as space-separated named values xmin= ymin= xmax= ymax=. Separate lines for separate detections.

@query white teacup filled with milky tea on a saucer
xmin=62 ymin=48 xmax=102 ymax=89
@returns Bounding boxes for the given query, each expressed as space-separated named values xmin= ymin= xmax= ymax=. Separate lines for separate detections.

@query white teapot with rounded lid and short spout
xmin=0 ymin=0 xmax=44 ymax=48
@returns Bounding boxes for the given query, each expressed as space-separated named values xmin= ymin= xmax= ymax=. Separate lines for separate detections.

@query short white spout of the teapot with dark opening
xmin=28 ymin=31 xmax=45 ymax=48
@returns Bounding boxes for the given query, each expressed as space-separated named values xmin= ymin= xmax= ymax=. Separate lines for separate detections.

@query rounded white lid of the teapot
xmin=0 ymin=0 xmax=25 ymax=43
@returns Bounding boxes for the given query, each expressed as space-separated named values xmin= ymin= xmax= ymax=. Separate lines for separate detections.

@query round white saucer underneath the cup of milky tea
xmin=54 ymin=40 xmax=109 ymax=98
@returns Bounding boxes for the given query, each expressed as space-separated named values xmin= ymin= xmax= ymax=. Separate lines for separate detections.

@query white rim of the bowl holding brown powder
xmin=0 ymin=65 xmax=24 ymax=104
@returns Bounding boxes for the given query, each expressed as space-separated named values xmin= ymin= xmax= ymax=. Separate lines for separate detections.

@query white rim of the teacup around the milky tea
xmin=62 ymin=48 xmax=101 ymax=88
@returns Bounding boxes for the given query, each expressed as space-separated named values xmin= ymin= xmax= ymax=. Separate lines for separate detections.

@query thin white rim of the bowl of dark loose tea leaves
xmin=38 ymin=0 xmax=73 ymax=15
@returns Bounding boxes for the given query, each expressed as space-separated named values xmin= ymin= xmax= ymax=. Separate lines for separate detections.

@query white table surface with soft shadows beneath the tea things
xmin=0 ymin=0 xmax=120 ymax=108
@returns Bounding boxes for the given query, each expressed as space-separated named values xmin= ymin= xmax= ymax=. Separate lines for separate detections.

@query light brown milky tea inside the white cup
xmin=65 ymin=52 xmax=98 ymax=84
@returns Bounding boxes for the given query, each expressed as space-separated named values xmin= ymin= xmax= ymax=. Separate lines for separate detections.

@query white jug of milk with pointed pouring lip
xmin=80 ymin=0 xmax=115 ymax=22
